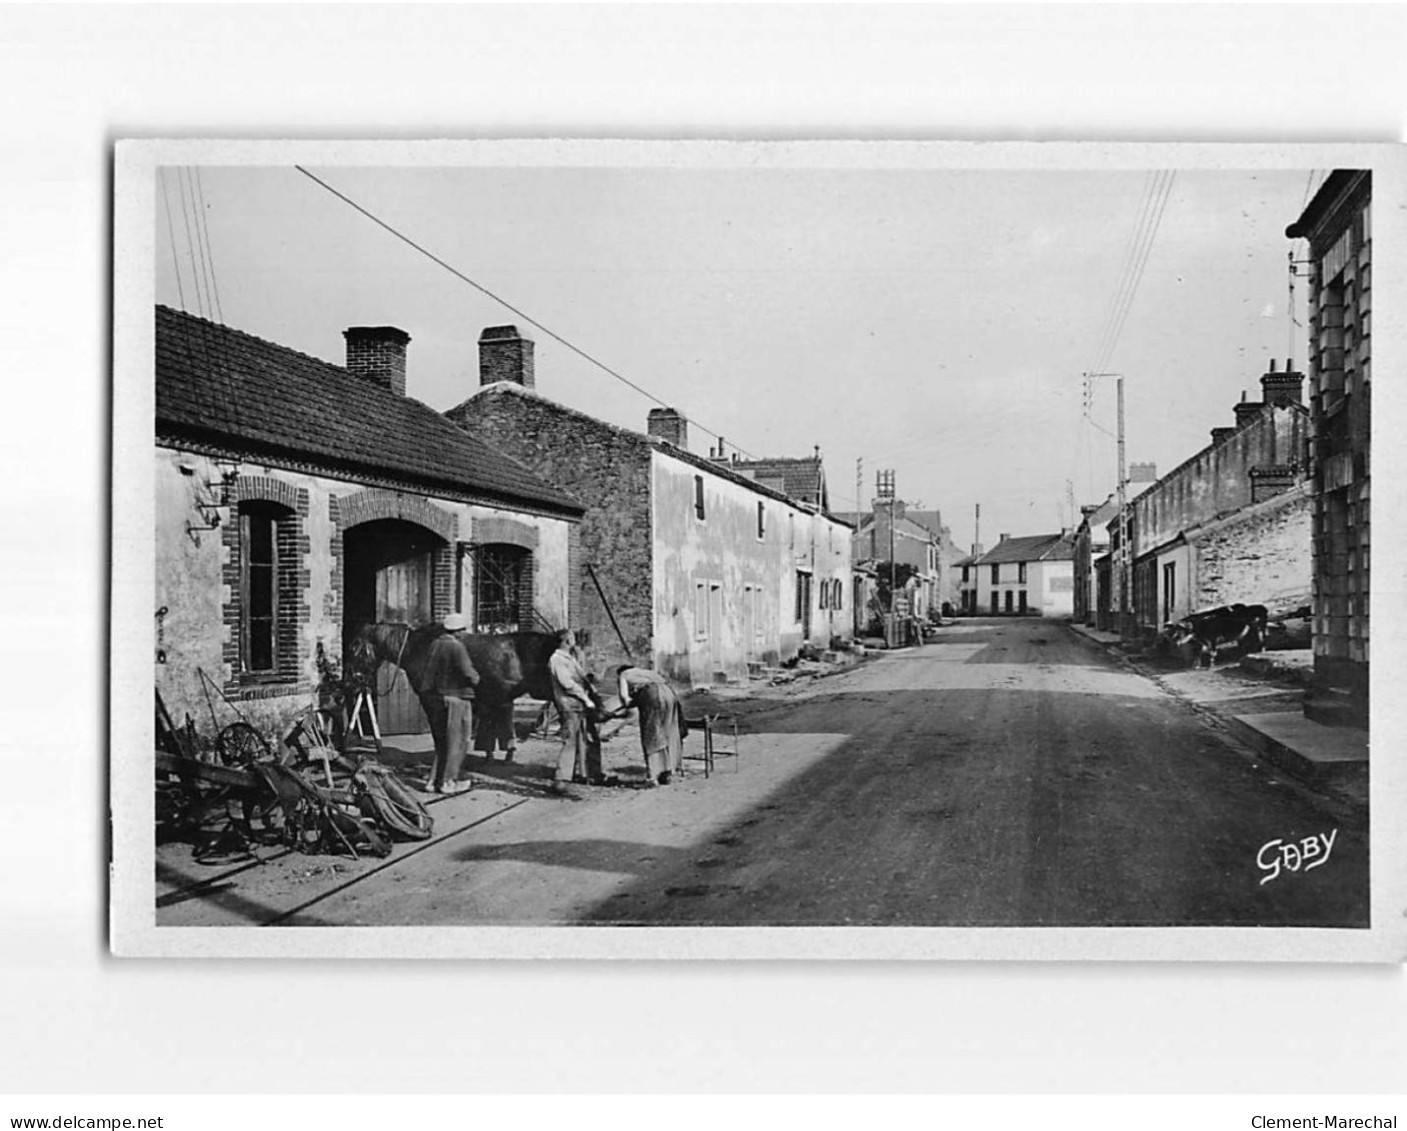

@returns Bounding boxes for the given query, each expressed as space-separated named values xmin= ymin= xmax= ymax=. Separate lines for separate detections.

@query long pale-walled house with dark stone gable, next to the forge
xmin=446 ymin=326 xmax=855 ymax=686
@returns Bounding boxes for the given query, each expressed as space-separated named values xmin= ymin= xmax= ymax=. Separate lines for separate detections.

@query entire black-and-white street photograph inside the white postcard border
xmin=149 ymin=156 xmax=1373 ymax=930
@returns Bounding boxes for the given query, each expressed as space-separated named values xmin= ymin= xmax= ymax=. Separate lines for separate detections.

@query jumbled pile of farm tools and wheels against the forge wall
xmin=156 ymin=672 xmax=433 ymax=864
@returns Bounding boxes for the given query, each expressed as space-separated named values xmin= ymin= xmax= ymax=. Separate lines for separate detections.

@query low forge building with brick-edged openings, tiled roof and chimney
xmin=155 ymin=307 xmax=581 ymax=734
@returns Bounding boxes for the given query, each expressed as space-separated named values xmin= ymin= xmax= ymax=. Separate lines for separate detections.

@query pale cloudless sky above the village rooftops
xmin=155 ymin=162 xmax=1327 ymax=549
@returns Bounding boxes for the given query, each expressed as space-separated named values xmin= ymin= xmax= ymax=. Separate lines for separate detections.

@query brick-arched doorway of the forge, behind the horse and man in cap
xmin=342 ymin=518 xmax=447 ymax=734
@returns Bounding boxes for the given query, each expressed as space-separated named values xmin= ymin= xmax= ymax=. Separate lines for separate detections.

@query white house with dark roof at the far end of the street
xmin=964 ymin=530 xmax=1075 ymax=616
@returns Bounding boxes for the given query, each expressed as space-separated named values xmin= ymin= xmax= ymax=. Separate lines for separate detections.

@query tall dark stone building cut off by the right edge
xmin=1285 ymin=169 xmax=1373 ymax=705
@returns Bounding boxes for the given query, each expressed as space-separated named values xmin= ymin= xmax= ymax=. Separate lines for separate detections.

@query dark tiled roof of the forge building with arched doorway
xmin=156 ymin=307 xmax=582 ymax=515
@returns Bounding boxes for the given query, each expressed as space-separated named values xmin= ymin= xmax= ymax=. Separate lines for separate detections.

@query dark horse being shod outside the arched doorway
xmin=348 ymin=622 xmax=557 ymax=754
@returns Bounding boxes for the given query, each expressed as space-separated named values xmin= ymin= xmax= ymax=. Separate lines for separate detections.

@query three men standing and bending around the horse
xmin=422 ymin=613 xmax=685 ymax=795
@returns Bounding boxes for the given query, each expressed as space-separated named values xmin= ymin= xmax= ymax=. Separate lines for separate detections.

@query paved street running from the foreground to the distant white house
xmin=279 ymin=620 xmax=1368 ymax=927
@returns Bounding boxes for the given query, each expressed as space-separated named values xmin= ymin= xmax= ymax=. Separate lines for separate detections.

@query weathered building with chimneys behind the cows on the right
xmin=1096 ymin=362 xmax=1310 ymax=634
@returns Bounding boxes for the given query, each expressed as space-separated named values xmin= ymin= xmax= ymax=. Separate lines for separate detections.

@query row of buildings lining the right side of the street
xmin=1074 ymin=169 xmax=1372 ymax=713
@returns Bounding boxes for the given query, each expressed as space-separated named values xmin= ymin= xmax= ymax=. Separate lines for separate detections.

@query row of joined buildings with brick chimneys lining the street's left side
xmin=155 ymin=307 xmax=854 ymax=733
